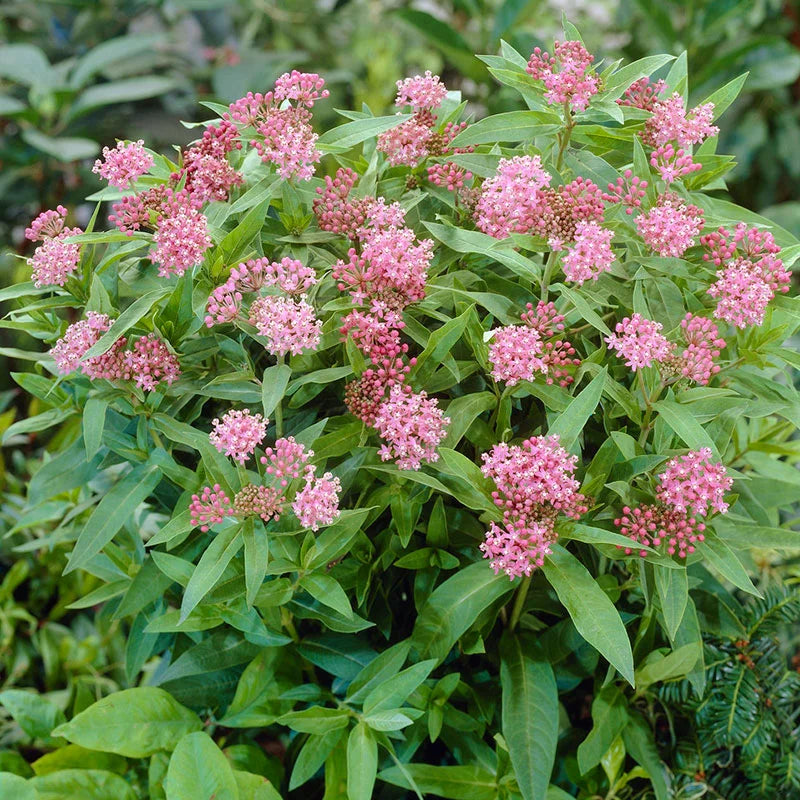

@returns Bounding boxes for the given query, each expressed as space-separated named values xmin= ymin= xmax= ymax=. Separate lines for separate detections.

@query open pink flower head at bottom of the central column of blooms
xmin=375 ymin=384 xmax=450 ymax=470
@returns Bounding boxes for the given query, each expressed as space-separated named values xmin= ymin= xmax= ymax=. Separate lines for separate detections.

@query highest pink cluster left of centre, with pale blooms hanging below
xmin=225 ymin=70 xmax=329 ymax=180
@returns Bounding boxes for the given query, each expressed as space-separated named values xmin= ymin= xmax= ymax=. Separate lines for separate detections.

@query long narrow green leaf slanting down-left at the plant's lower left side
xmin=64 ymin=464 xmax=161 ymax=575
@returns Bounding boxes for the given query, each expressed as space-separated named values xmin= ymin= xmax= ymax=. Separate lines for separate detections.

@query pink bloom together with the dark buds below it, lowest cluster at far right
xmin=614 ymin=448 xmax=733 ymax=558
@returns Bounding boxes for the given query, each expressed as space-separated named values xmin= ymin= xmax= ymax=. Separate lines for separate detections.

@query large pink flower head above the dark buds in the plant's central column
xmin=333 ymin=227 xmax=433 ymax=309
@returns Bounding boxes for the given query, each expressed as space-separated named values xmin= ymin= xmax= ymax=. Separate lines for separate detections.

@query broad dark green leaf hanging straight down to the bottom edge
xmin=500 ymin=634 xmax=558 ymax=800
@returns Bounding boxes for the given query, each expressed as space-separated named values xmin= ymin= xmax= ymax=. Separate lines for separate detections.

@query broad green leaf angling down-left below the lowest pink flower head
xmin=411 ymin=561 xmax=516 ymax=673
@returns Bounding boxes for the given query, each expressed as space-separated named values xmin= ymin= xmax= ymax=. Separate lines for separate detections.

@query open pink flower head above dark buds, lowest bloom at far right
xmin=656 ymin=447 xmax=733 ymax=517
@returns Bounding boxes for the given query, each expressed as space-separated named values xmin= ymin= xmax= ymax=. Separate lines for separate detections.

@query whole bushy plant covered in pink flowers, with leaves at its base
xmin=0 ymin=17 xmax=800 ymax=800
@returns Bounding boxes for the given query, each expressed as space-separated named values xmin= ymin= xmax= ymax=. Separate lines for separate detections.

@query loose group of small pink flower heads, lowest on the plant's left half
xmin=195 ymin=432 xmax=342 ymax=531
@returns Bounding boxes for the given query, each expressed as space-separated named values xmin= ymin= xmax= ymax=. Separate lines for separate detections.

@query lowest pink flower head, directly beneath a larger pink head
xmin=480 ymin=520 xmax=558 ymax=580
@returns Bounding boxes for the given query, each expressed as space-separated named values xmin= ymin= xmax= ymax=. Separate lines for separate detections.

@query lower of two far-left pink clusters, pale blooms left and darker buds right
xmin=50 ymin=311 xmax=181 ymax=391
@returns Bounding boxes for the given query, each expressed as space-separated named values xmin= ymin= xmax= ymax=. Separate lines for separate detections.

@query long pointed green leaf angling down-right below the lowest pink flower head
xmin=542 ymin=545 xmax=634 ymax=686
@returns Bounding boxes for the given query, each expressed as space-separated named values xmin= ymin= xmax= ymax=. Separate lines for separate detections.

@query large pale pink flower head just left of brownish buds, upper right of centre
xmin=475 ymin=156 xmax=551 ymax=239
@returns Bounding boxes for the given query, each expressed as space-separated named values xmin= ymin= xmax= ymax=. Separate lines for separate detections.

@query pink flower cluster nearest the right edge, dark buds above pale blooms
xmin=700 ymin=222 xmax=791 ymax=328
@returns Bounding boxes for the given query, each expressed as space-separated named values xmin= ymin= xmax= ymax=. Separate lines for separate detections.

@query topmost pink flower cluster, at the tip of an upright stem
xmin=525 ymin=41 xmax=600 ymax=111
